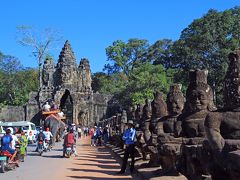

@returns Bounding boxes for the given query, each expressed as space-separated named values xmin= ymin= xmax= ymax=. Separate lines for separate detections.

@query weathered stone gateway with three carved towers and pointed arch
xmin=26 ymin=41 xmax=111 ymax=126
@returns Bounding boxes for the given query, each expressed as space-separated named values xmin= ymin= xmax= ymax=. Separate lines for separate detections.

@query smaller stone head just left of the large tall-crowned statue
xmin=167 ymin=84 xmax=185 ymax=115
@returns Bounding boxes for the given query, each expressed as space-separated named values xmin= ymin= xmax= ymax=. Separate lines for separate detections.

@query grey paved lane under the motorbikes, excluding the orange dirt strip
xmin=0 ymin=143 xmax=69 ymax=180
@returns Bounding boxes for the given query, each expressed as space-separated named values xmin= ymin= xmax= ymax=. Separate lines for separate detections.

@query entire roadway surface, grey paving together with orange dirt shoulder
xmin=0 ymin=138 xmax=135 ymax=180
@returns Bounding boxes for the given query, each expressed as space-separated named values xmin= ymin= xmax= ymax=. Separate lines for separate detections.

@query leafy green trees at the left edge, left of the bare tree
xmin=0 ymin=53 xmax=38 ymax=105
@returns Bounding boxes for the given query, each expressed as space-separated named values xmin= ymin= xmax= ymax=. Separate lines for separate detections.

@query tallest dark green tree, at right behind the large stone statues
xmin=171 ymin=7 xmax=240 ymax=105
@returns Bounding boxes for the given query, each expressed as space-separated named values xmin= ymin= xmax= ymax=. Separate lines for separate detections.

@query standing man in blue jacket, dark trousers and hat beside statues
xmin=118 ymin=120 xmax=136 ymax=174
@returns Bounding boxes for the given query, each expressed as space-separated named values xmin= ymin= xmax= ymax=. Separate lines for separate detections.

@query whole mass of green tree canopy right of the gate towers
xmin=94 ymin=7 xmax=240 ymax=106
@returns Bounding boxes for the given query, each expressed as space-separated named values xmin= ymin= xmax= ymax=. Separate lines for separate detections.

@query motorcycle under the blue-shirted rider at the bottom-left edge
xmin=0 ymin=150 xmax=18 ymax=173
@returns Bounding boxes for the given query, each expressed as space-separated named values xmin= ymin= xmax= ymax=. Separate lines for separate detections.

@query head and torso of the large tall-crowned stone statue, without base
xmin=179 ymin=70 xmax=215 ymax=138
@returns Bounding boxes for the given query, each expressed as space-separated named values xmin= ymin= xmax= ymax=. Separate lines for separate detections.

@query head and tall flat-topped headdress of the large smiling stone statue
xmin=186 ymin=69 xmax=214 ymax=112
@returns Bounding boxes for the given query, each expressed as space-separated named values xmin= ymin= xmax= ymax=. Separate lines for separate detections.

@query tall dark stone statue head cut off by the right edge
xmin=224 ymin=50 xmax=240 ymax=109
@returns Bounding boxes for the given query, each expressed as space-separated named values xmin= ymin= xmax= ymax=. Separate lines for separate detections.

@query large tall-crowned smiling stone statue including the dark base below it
xmin=177 ymin=70 xmax=214 ymax=179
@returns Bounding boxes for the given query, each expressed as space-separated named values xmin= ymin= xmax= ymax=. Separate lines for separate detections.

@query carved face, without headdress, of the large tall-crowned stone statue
xmin=189 ymin=90 xmax=209 ymax=112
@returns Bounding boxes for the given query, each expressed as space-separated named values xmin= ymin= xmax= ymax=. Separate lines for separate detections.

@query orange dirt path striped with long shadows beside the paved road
xmin=58 ymin=138 xmax=132 ymax=180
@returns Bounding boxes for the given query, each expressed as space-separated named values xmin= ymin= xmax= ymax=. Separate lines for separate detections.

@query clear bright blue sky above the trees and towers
xmin=0 ymin=0 xmax=240 ymax=72
